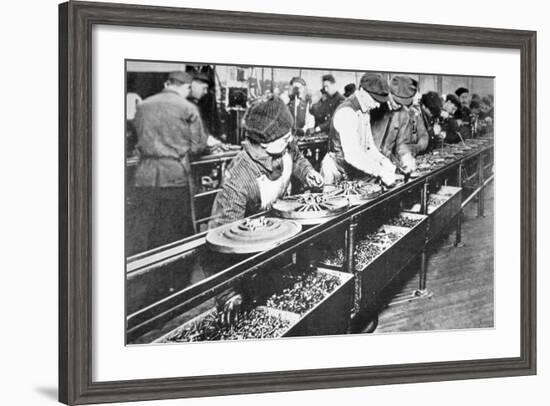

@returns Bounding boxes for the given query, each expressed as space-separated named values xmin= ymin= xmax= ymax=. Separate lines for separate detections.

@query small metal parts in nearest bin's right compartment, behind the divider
xmin=266 ymin=272 xmax=341 ymax=315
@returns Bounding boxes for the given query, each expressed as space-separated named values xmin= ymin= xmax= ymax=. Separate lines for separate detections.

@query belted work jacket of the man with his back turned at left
xmin=134 ymin=89 xmax=208 ymax=187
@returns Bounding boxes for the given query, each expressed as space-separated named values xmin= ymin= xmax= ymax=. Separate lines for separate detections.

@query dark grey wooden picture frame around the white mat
xmin=59 ymin=1 xmax=536 ymax=405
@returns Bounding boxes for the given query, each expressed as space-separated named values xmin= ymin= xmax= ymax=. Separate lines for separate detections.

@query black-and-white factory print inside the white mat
xmin=125 ymin=60 xmax=495 ymax=345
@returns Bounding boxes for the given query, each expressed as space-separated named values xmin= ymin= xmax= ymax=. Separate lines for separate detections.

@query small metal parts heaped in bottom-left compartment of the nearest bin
xmin=166 ymin=308 xmax=290 ymax=342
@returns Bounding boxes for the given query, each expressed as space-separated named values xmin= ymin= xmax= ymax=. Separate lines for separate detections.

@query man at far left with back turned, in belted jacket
xmin=132 ymin=71 xmax=207 ymax=252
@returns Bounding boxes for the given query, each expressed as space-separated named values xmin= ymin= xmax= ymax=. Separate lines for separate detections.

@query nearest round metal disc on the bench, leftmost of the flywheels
xmin=206 ymin=216 xmax=302 ymax=254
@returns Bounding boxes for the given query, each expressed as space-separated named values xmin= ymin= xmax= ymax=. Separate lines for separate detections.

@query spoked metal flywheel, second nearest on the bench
xmin=272 ymin=193 xmax=349 ymax=224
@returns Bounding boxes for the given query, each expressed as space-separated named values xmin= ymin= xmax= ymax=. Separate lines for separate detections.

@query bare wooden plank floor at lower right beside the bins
xmin=375 ymin=185 xmax=494 ymax=333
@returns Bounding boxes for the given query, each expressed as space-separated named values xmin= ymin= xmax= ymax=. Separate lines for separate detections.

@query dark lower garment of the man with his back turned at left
xmin=126 ymin=186 xmax=193 ymax=256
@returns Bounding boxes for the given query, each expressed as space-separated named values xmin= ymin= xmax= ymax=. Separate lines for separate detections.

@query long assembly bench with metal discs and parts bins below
xmin=126 ymin=134 xmax=494 ymax=344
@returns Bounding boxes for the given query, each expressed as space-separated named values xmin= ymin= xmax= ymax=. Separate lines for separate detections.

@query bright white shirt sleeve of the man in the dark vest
xmin=334 ymin=107 xmax=385 ymax=176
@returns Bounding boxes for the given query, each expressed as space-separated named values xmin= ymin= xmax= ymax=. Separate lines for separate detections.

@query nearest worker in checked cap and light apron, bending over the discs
xmin=208 ymin=96 xmax=323 ymax=228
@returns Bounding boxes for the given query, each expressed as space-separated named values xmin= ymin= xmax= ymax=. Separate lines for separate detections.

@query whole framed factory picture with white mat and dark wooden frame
xmin=59 ymin=1 xmax=536 ymax=405
